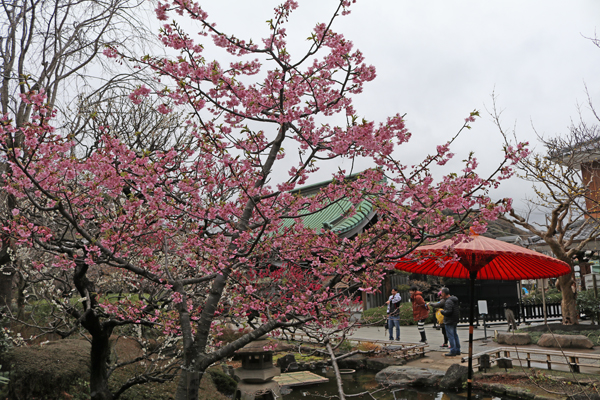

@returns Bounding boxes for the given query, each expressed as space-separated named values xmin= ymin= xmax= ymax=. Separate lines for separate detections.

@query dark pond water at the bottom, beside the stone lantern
xmin=282 ymin=371 xmax=501 ymax=400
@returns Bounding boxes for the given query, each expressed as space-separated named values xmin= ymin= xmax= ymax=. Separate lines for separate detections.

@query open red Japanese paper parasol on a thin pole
xmin=396 ymin=235 xmax=571 ymax=399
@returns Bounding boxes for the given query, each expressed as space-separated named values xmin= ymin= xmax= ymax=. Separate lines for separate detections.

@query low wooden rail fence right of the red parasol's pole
xmin=461 ymin=347 xmax=600 ymax=372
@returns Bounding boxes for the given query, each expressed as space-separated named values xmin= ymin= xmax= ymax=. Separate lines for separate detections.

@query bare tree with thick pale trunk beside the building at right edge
xmin=496 ymin=98 xmax=600 ymax=324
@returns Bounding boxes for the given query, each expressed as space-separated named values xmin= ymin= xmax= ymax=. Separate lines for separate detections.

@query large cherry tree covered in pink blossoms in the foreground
xmin=0 ymin=0 xmax=527 ymax=399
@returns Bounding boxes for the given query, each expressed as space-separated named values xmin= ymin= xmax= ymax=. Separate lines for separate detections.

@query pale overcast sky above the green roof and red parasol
xmin=162 ymin=0 xmax=600 ymax=227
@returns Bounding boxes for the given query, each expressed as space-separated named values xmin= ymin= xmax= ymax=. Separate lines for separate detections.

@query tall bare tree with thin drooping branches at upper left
xmin=0 ymin=0 xmax=154 ymax=305
